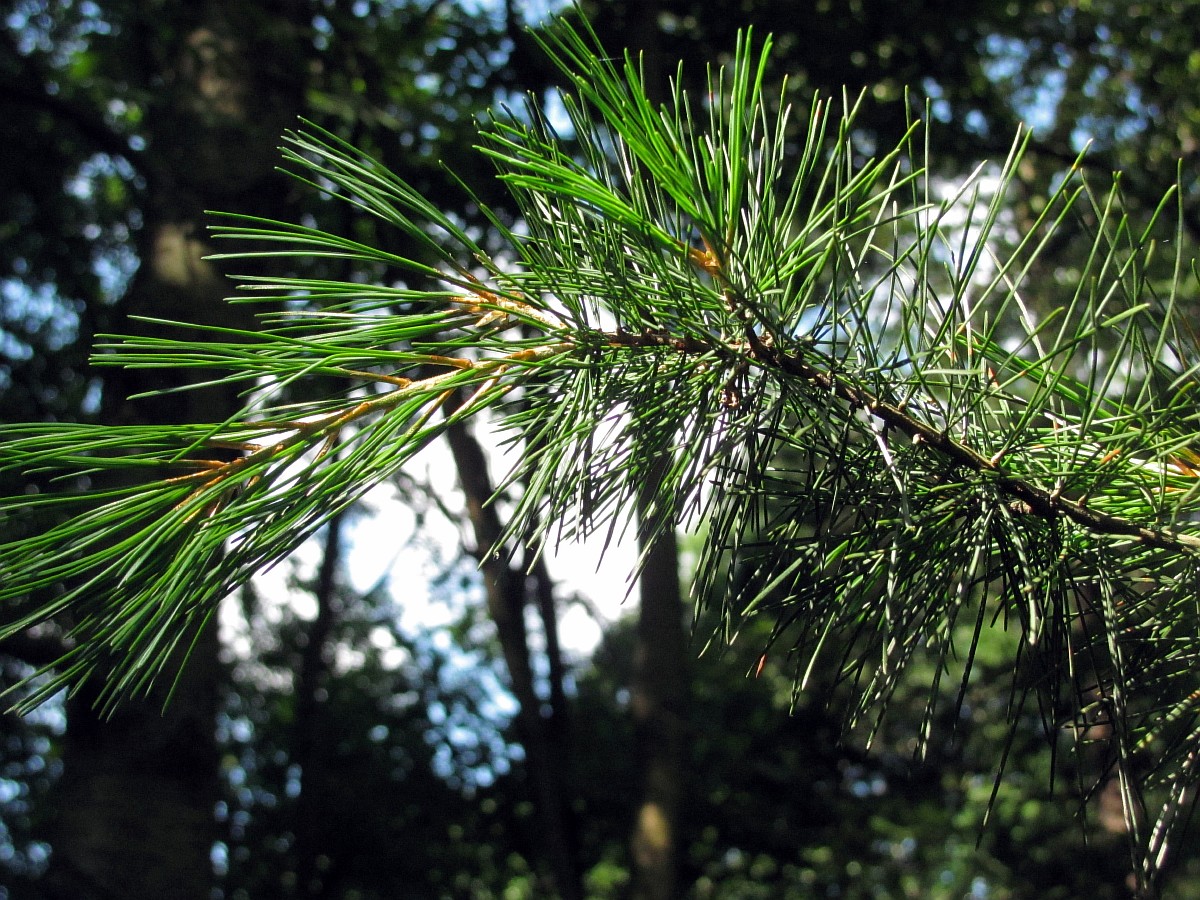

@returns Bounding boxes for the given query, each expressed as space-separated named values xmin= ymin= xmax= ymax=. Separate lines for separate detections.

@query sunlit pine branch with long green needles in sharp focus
xmin=0 ymin=8 xmax=1200 ymax=892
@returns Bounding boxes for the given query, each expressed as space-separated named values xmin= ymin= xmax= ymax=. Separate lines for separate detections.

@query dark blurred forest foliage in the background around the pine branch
xmin=0 ymin=0 xmax=1200 ymax=900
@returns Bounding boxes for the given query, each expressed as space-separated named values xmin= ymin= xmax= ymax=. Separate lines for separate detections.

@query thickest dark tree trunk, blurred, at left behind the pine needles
xmin=46 ymin=0 xmax=305 ymax=900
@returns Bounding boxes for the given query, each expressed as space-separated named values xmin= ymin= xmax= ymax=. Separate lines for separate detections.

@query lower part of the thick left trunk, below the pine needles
xmin=46 ymin=629 xmax=221 ymax=900
